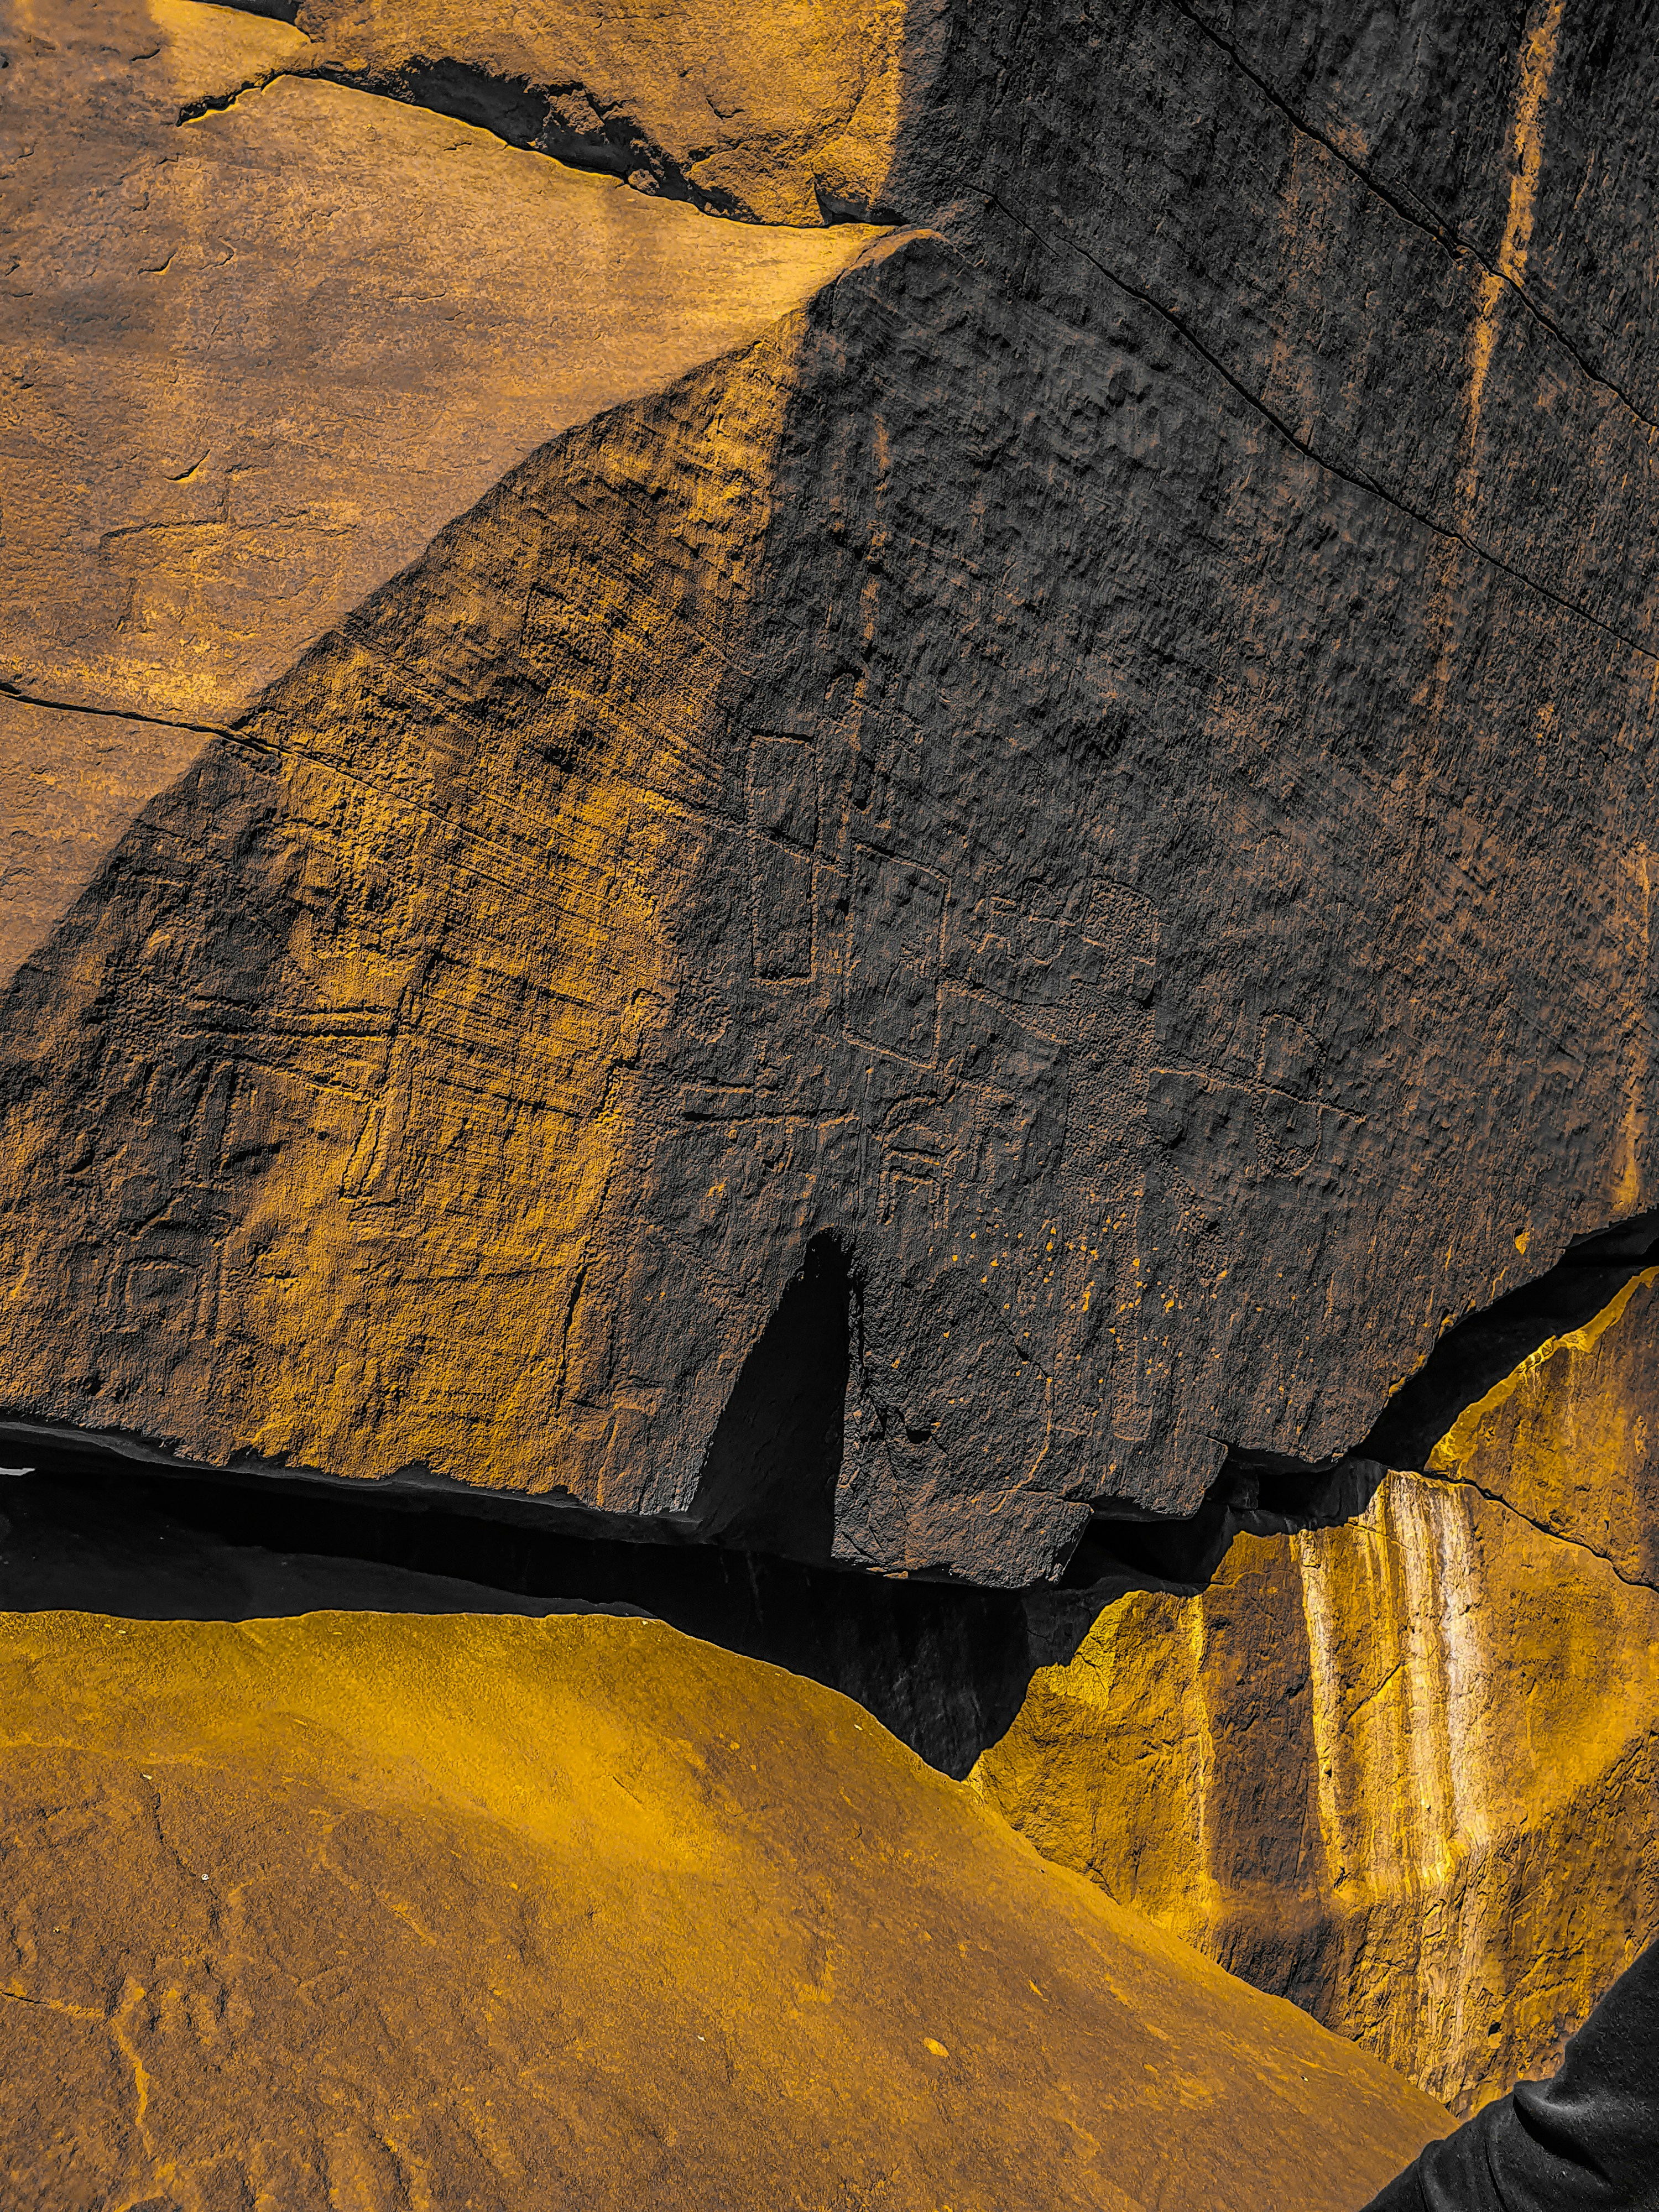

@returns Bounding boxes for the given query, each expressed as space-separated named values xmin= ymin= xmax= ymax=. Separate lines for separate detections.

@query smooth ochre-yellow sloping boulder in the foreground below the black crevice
xmin=0 ymin=1615 xmax=1447 ymax=2212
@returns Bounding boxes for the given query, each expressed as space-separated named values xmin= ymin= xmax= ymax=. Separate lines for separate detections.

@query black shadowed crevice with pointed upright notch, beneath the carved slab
xmin=0 ymin=1217 xmax=1659 ymax=1776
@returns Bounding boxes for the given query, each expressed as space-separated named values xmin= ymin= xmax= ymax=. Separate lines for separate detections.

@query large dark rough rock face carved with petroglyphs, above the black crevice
xmin=0 ymin=0 xmax=1659 ymax=1584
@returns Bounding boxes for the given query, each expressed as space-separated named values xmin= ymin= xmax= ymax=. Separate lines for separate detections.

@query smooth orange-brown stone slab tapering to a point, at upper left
xmin=0 ymin=0 xmax=872 ymax=975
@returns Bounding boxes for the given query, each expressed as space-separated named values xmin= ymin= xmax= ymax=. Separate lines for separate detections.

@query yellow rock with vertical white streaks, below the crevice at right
xmin=973 ymin=1270 xmax=1659 ymax=2110
